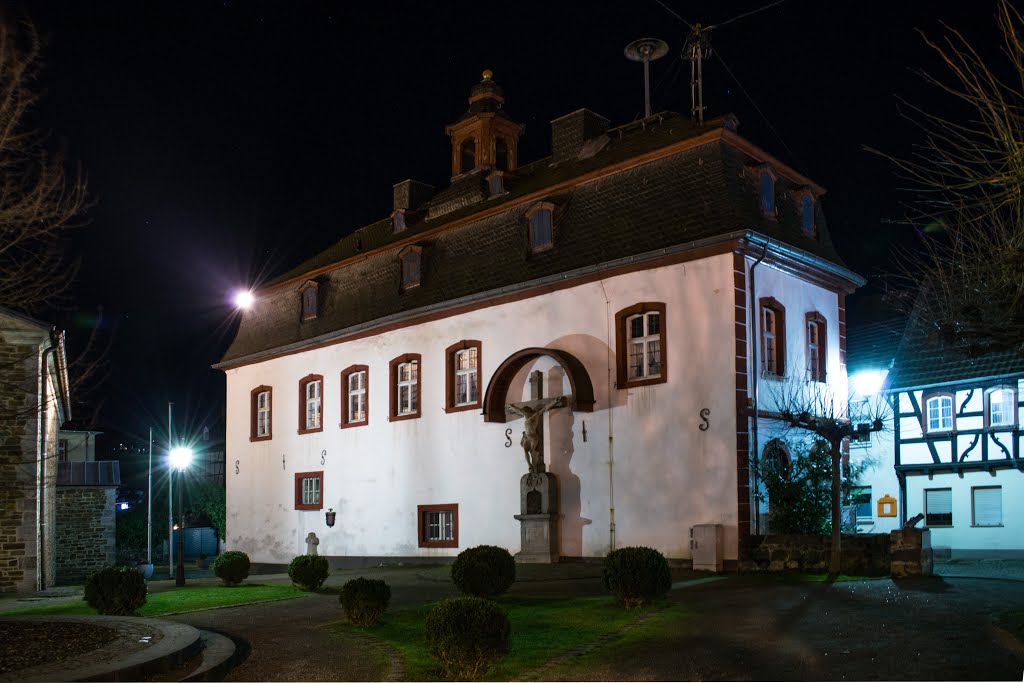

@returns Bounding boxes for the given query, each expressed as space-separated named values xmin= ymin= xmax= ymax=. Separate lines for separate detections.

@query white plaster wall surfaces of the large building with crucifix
xmin=226 ymin=254 xmax=846 ymax=563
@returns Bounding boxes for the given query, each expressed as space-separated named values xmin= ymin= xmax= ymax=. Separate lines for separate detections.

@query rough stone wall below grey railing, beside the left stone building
xmin=56 ymin=486 xmax=117 ymax=586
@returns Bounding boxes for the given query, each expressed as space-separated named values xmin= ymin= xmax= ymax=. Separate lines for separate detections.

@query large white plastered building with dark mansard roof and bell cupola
xmin=218 ymin=74 xmax=863 ymax=566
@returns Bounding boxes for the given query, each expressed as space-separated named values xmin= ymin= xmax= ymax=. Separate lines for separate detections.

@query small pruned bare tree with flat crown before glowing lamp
xmin=766 ymin=379 xmax=889 ymax=582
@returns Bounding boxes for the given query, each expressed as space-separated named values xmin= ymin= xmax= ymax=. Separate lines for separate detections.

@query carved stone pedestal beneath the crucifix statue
xmin=515 ymin=472 xmax=558 ymax=564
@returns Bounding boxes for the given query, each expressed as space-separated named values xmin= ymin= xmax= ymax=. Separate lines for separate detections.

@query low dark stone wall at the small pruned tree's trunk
xmin=739 ymin=533 xmax=890 ymax=577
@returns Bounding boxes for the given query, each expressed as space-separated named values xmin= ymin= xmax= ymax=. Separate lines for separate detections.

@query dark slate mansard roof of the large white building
xmin=218 ymin=113 xmax=860 ymax=367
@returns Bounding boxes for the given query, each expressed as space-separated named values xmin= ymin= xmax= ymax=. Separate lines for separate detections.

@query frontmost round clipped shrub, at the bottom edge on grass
xmin=426 ymin=598 xmax=512 ymax=680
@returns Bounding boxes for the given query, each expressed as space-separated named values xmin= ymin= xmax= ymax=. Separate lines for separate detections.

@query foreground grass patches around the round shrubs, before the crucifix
xmin=333 ymin=596 xmax=687 ymax=681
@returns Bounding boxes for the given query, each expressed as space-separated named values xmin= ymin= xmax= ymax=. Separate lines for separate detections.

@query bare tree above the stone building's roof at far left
xmin=0 ymin=15 xmax=88 ymax=310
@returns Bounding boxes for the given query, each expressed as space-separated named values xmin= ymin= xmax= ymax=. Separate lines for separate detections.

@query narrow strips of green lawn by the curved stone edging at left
xmin=0 ymin=584 xmax=312 ymax=616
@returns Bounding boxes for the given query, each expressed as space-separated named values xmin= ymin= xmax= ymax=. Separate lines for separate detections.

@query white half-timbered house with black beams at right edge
xmin=889 ymin=325 xmax=1024 ymax=557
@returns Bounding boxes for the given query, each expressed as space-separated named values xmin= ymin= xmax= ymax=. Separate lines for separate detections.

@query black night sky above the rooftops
xmin=26 ymin=0 xmax=995 ymax=446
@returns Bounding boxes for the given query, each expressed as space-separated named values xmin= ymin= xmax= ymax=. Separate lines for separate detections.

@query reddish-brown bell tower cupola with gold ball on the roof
xmin=444 ymin=70 xmax=524 ymax=178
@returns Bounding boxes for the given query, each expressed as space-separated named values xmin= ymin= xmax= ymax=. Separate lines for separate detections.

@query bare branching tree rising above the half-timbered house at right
xmin=870 ymin=0 xmax=1024 ymax=356
